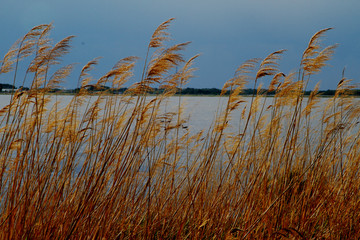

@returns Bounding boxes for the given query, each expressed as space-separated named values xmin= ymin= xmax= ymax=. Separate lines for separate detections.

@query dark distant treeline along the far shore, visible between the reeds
xmin=0 ymin=83 xmax=360 ymax=96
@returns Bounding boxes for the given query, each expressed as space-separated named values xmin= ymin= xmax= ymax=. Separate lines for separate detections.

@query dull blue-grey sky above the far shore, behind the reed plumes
xmin=0 ymin=0 xmax=360 ymax=90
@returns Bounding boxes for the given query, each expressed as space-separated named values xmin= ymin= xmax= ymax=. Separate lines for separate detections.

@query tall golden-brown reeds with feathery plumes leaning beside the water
xmin=0 ymin=19 xmax=360 ymax=239
